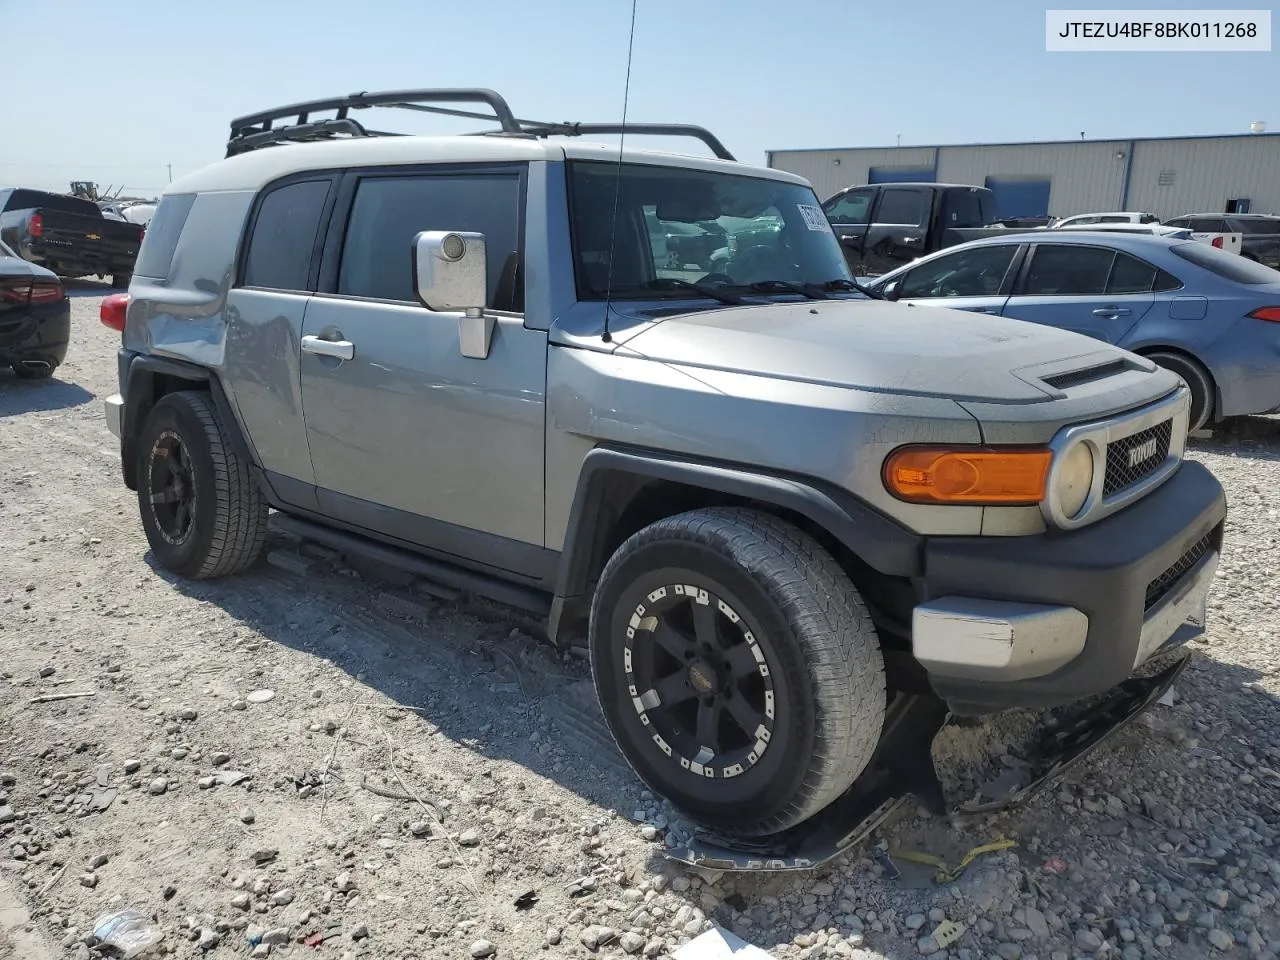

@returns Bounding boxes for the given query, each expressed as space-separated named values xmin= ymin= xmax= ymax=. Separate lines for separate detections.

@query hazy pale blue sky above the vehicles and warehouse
xmin=0 ymin=0 xmax=1280 ymax=193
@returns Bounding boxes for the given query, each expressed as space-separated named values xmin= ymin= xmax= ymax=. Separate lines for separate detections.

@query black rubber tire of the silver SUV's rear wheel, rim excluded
xmin=137 ymin=390 xmax=268 ymax=580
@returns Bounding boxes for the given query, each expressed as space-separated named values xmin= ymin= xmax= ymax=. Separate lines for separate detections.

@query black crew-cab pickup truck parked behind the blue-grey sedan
xmin=822 ymin=183 xmax=1013 ymax=276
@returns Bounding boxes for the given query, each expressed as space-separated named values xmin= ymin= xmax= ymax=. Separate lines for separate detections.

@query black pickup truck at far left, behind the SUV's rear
xmin=0 ymin=188 xmax=145 ymax=287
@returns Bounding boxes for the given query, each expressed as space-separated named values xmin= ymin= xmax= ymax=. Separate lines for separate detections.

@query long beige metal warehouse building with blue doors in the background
xmin=768 ymin=133 xmax=1280 ymax=219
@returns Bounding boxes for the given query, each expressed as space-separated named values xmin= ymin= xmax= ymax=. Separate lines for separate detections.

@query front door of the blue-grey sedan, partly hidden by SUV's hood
xmin=893 ymin=243 xmax=1023 ymax=314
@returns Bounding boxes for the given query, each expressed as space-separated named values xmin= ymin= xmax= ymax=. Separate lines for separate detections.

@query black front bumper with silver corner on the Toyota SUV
xmin=911 ymin=462 xmax=1226 ymax=714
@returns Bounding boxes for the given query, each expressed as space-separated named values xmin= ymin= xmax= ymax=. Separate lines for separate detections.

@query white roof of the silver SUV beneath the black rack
xmin=165 ymin=136 xmax=809 ymax=193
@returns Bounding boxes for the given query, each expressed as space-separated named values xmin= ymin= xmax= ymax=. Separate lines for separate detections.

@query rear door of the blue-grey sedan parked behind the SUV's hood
xmin=1004 ymin=243 xmax=1160 ymax=343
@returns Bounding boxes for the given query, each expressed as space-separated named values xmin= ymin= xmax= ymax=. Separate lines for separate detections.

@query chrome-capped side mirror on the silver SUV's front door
xmin=413 ymin=230 xmax=495 ymax=360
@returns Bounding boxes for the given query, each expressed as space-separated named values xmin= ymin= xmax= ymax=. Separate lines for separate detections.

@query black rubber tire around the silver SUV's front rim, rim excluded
xmin=589 ymin=507 xmax=886 ymax=837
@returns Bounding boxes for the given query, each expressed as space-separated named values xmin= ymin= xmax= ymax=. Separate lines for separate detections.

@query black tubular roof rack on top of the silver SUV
xmin=227 ymin=88 xmax=736 ymax=160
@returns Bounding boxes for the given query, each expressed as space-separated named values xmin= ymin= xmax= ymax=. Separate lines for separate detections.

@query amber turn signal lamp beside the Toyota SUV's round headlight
xmin=884 ymin=447 xmax=1053 ymax=506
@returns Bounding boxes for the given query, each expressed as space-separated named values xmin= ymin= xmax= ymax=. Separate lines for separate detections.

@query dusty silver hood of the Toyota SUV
xmin=614 ymin=300 xmax=1153 ymax=403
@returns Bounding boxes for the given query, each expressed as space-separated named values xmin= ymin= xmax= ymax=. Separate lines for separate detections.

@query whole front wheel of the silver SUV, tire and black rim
xmin=589 ymin=508 xmax=884 ymax=836
